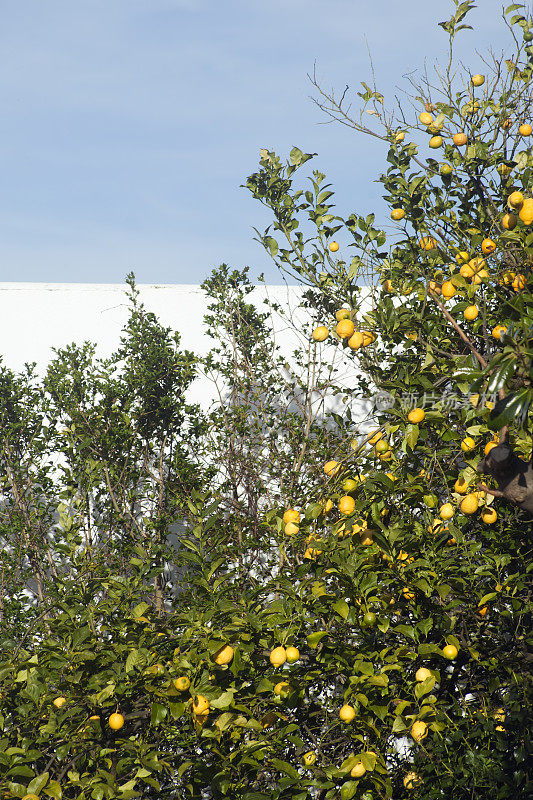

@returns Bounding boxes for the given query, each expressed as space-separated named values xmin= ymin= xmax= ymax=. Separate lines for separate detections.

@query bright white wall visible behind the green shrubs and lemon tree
xmin=0 ymin=282 xmax=362 ymax=408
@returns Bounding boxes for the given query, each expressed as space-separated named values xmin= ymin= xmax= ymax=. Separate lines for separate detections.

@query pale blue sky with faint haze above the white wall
xmin=0 ymin=0 xmax=508 ymax=283
